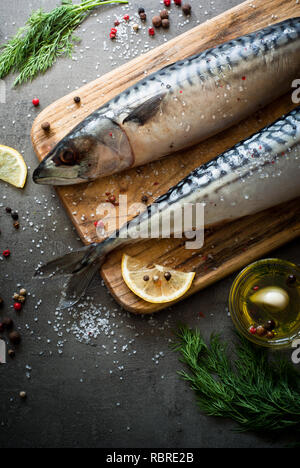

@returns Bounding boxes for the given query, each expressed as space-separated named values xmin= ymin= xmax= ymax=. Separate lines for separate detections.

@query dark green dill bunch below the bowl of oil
xmin=175 ymin=326 xmax=300 ymax=431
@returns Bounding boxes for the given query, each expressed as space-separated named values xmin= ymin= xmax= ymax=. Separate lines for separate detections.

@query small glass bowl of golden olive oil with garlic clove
xmin=229 ymin=259 xmax=300 ymax=348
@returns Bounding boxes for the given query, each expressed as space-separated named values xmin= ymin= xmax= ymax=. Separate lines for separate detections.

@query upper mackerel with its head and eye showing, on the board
xmin=33 ymin=18 xmax=300 ymax=185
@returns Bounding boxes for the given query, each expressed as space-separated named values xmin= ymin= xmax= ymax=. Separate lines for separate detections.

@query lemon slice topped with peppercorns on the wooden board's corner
xmin=122 ymin=254 xmax=195 ymax=304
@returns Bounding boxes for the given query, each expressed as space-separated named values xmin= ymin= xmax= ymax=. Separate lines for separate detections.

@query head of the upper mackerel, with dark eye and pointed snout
xmin=33 ymin=113 xmax=134 ymax=185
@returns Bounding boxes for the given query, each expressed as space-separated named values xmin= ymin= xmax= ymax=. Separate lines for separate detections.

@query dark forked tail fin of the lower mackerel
xmin=35 ymin=241 xmax=109 ymax=309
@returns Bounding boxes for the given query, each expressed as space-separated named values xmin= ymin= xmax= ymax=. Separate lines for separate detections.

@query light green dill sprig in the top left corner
xmin=0 ymin=0 xmax=128 ymax=86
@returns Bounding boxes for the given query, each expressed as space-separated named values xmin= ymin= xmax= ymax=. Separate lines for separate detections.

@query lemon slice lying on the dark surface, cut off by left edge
xmin=0 ymin=145 xmax=27 ymax=188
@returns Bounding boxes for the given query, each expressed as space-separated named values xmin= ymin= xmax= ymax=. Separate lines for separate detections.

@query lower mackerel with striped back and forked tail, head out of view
xmin=37 ymin=106 xmax=300 ymax=308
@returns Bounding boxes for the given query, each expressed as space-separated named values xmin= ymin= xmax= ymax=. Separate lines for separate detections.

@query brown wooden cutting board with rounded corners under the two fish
xmin=31 ymin=0 xmax=300 ymax=313
